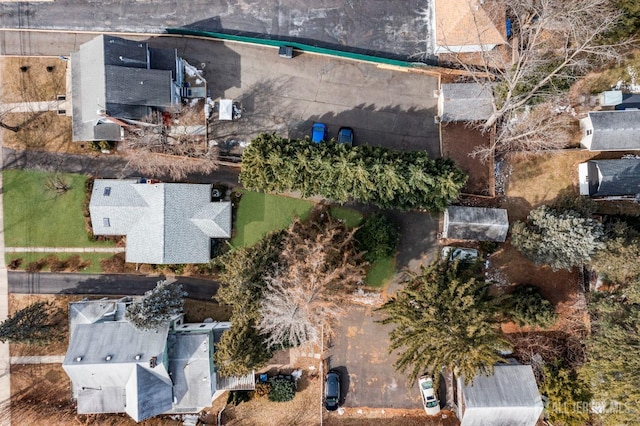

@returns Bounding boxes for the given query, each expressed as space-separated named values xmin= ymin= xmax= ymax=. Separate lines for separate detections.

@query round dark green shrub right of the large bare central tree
xmin=355 ymin=213 xmax=399 ymax=263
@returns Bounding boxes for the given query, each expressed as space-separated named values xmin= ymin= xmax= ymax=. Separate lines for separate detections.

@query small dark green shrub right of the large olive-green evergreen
xmin=505 ymin=286 xmax=557 ymax=328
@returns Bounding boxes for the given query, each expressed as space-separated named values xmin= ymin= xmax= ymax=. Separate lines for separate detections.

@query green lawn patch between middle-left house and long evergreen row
xmin=231 ymin=191 xmax=313 ymax=247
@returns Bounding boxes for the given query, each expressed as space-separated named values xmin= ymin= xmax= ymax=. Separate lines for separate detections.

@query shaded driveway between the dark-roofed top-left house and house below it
xmin=2 ymin=148 xmax=239 ymax=187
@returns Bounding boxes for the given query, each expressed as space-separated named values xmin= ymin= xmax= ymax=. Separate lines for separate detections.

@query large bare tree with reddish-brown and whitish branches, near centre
xmin=258 ymin=213 xmax=364 ymax=347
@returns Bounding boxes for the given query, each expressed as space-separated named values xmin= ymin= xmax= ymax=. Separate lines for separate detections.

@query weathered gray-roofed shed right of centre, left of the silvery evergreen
xmin=442 ymin=206 xmax=509 ymax=242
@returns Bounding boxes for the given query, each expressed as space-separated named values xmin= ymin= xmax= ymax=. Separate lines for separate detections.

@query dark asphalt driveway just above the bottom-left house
xmin=9 ymin=271 xmax=219 ymax=300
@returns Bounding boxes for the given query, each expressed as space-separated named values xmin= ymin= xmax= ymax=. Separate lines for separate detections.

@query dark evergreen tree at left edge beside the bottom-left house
xmin=0 ymin=302 xmax=64 ymax=345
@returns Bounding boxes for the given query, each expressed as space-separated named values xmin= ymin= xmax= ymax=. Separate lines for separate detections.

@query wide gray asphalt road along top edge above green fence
xmin=0 ymin=0 xmax=433 ymax=57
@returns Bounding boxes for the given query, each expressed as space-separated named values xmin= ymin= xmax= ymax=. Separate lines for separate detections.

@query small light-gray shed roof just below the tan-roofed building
xmin=438 ymin=83 xmax=493 ymax=123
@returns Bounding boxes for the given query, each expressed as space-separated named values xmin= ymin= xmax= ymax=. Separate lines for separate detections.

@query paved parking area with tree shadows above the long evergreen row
xmin=151 ymin=37 xmax=440 ymax=157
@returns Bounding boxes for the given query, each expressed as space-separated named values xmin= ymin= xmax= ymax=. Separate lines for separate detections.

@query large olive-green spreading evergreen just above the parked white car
xmin=380 ymin=261 xmax=510 ymax=383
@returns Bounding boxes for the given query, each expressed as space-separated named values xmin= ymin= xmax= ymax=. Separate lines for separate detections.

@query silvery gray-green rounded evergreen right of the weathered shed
xmin=511 ymin=206 xmax=604 ymax=271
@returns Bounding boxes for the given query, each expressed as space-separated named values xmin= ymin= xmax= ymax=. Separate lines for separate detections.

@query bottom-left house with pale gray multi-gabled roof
xmin=62 ymin=298 xmax=255 ymax=422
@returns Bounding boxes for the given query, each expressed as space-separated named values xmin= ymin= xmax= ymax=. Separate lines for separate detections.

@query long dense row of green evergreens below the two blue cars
xmin=240 ymin=133 xmax=467 ymax=212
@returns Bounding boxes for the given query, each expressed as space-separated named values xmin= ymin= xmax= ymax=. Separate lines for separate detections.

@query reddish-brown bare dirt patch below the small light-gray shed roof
xmin=440 ymin=123 xmax=495 ymax=196
